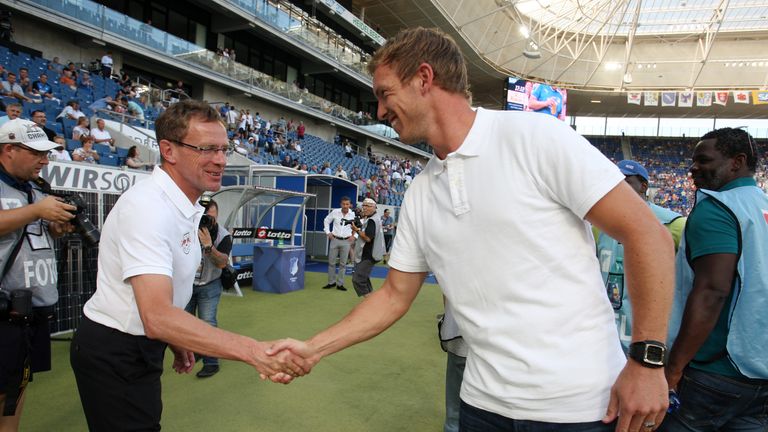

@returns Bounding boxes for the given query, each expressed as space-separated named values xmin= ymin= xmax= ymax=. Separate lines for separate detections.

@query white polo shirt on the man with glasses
xmin=83 ymin=166 xmax=204 ymax=335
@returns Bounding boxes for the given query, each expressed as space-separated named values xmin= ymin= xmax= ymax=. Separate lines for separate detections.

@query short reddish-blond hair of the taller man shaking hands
xmin=368 ymin=27 xmax=472 ymax=100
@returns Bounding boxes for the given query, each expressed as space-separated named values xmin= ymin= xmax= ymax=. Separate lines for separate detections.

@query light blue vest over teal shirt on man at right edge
xmin=669 ymin=186 xmax=768 ymax=379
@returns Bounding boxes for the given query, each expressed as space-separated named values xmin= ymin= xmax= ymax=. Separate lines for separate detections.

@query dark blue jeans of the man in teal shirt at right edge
xmin=659 ymin=368 xmax=768 ymax=432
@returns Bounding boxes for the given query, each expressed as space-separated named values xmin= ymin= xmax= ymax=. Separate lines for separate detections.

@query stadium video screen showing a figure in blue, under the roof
xmin=504 ymin=77 xmax=568 ymax=120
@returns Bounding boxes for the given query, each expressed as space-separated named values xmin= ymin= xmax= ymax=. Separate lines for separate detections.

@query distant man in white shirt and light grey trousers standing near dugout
xmin=323 ymin=197 xmax=355 ymax=291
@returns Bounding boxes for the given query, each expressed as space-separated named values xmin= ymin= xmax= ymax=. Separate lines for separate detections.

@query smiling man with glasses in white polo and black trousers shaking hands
xmin=70 ymin=100 xmax=308 ymax=431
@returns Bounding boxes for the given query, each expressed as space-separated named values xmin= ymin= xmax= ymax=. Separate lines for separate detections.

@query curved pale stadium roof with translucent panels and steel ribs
xmin=352 ymin=0 xmax=768 ymax=118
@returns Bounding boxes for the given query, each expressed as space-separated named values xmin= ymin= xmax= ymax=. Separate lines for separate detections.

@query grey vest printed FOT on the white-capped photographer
xmin=0 ymin=172 xmax=59 ymax=307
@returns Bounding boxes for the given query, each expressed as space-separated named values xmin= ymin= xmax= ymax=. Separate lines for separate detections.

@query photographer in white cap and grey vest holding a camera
xmin=0 ymin=119 xmax=76 ymax=431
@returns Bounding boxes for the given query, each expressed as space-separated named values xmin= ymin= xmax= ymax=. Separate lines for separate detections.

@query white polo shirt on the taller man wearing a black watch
xmin=389 ymin=109 xmax=625 ymax=423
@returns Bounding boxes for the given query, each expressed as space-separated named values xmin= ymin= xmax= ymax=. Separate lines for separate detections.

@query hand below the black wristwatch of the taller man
xmin=603 ymin=360 xmax=669 ymax=432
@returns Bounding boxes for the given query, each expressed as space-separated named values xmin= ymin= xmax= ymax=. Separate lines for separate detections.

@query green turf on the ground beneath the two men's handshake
xmin=21 ymin=272 xmax=445 ymax=432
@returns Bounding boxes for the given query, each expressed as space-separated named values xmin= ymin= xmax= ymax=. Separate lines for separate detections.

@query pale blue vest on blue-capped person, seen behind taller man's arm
xmin=597 ymin=202 xmax=682 ymax=352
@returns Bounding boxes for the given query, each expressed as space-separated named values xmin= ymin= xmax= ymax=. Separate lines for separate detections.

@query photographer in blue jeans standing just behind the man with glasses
xmin=184 ymin=200 xmax=232 ymax=378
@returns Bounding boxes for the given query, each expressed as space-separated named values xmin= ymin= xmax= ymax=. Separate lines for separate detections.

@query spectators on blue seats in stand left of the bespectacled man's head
xmin=0 ymin=50 xmax=166 ymax=167
